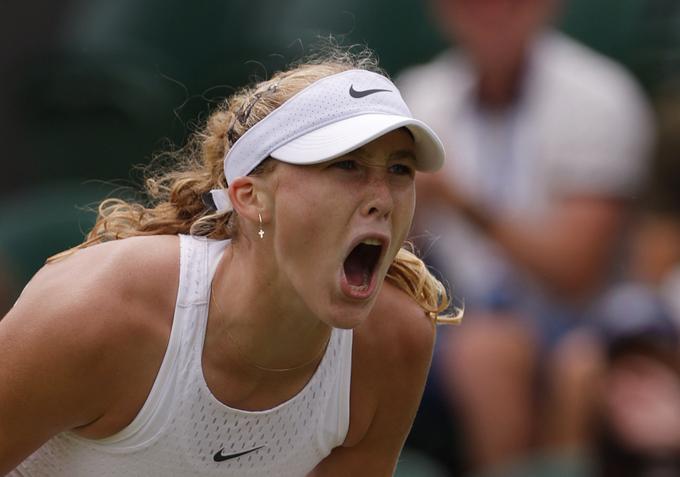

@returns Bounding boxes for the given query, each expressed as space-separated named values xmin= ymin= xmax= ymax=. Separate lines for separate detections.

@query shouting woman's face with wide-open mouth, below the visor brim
xmin=268 ymin=129 xmax=415 ymax=328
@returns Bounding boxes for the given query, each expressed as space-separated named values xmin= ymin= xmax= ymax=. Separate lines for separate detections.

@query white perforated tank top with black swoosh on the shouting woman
xmin=9 ymin=236 xmax=352 ymax=477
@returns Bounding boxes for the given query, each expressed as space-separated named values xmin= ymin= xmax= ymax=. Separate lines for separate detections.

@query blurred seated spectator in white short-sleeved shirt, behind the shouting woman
xmin=399 ymin=0 xmax=652 ymax=474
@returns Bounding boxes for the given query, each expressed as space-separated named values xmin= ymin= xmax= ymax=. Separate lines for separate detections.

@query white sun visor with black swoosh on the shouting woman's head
xmin=213 ymin=70 xmax=444 ymax=210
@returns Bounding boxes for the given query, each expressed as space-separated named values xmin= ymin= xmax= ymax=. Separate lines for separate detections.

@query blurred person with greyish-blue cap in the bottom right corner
xmin=595 ymin=284 xmax=680 ymax=477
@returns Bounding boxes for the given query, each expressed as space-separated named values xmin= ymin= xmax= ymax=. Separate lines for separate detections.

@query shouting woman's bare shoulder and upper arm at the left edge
xmin=0 ymin=237 xmax=179 ymax=464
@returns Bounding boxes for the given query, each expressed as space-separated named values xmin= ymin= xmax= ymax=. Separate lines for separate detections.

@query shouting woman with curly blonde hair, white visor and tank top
xmin=0 ymin=49 xmax=456 ymax=476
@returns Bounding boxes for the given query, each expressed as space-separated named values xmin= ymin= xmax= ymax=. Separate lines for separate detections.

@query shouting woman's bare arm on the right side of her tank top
xmin=310 ymin=284 xmax=435 ymax=477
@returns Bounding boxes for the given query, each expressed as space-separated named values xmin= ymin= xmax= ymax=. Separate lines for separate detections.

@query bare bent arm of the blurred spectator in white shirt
xmin=418 ymin=172 xmax=625 ymax=298
